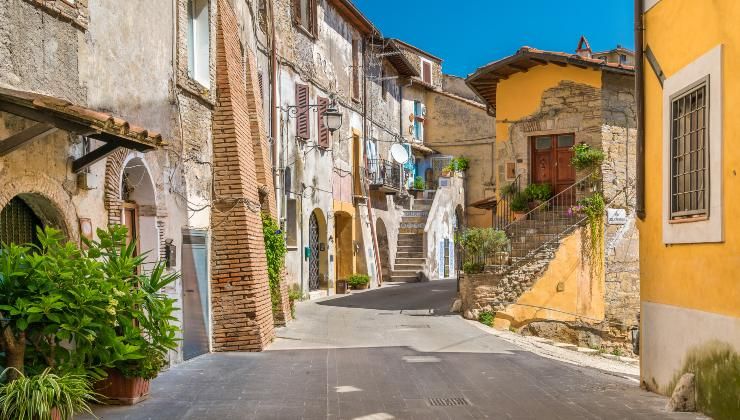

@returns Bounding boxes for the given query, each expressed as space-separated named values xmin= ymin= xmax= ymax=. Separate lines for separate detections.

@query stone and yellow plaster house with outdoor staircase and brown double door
xmin=463 ymin=39 xmax=639 ymax=351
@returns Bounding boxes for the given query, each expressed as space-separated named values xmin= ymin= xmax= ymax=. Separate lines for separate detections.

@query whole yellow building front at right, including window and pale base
xmin=637 ymin=0 xmax=740 ymax=418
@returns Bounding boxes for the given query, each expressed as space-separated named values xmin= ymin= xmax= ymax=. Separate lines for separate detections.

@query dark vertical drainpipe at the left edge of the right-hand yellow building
xmin=635 ymin=0 xmax=645 ymax=220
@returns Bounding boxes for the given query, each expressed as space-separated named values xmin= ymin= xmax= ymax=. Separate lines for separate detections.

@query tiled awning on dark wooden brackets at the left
xmin=0 ymin=87 xmax=165 ymax=172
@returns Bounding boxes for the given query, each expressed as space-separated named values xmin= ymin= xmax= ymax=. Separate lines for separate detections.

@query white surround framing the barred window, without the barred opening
xmin=662 ymin=44 xmax=724 ymax=244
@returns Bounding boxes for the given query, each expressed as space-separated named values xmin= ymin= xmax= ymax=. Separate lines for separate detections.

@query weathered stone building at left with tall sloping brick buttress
xmin=0 ymin=0 xmax=289 ymax=363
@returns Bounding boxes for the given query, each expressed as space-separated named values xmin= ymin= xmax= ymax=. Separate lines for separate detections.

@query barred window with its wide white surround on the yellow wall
xmin=660 ymin=44 xmax=730 ymax=244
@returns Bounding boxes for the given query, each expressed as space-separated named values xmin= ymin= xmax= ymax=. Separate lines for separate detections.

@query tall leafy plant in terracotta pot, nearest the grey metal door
xmin=89 ymin=226 xmax=179 ymax=405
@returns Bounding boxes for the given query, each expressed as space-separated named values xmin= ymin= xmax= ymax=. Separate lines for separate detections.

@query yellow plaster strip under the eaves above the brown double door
xmin=496 ymin=64 xmax=601 ymax=141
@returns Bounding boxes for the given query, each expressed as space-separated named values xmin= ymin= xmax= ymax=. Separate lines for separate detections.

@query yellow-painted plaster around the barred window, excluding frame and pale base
xmin=638 ymin=0 xmax=740 ymax=317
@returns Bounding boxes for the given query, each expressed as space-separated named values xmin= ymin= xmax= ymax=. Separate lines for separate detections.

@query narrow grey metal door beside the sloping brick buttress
xmin=182 ymin=230 xmax=209 ymax=360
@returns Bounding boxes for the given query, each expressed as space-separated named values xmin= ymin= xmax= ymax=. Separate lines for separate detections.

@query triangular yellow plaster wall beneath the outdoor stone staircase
xmin=494 ymin=229 xmax=604 ymax=328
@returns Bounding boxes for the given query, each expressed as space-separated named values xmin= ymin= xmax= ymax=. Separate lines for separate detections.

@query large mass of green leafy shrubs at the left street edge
xmin=0 ymin=226 xmax=178 ymax=381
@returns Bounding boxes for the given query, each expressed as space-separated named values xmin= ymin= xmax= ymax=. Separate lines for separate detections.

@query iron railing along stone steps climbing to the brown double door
xmin=458 ymin=175 xmax=600 ymax=274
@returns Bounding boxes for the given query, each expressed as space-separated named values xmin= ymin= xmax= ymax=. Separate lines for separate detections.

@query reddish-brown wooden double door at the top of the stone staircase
xmin=532 ymin=134 xmax=576 ymax=200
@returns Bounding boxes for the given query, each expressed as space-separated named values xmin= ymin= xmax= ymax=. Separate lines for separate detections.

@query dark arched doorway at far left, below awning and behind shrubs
xmin=0 ymin=193 xmax=69 ymax=245
